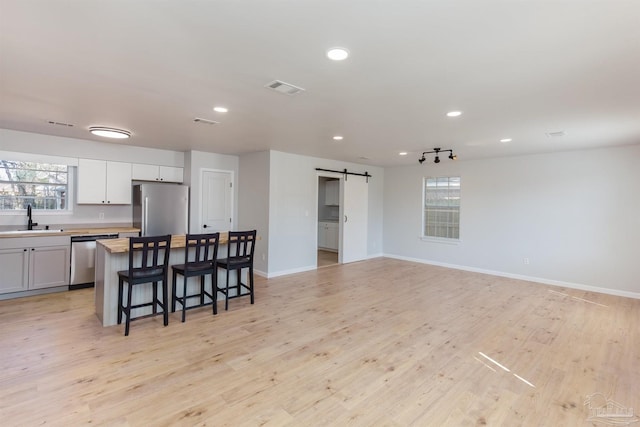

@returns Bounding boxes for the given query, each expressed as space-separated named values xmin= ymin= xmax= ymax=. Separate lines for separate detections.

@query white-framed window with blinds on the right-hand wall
xmin=422 ymin=176 xmax=460 ymax=240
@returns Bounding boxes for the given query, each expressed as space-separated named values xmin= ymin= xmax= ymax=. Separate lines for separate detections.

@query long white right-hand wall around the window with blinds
xmin=384 ymin=146 xmax=640 ymax=297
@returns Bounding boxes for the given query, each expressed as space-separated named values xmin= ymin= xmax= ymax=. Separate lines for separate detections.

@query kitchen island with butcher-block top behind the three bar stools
xmin=94 ymin=232 xmax=235 ymax=326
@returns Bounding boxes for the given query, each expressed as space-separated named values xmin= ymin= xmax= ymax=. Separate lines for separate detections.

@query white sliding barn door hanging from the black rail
xmin=340 ymin=175 xmax=369 ymax=263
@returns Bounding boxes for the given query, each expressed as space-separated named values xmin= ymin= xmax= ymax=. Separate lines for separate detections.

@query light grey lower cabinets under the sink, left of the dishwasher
xmin=0 ymin=236 xmax=71 ymax=293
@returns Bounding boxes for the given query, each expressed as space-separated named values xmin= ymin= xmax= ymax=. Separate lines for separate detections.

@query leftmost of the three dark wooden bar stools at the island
xmin=118 ymin=235 xmax=171 ymax=336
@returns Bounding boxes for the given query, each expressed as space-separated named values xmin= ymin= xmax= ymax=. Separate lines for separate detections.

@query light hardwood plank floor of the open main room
xmin=0 ymin=258 xmax=640 ymax=426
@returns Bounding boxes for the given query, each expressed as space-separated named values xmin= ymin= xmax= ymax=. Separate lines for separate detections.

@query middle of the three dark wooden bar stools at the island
xmin=171 ymin=233 xmax=220 ymax=322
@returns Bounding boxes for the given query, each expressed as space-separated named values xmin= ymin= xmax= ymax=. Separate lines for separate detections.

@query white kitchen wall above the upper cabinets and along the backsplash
xmin=0 ymin=129 xmax=184 ymax=229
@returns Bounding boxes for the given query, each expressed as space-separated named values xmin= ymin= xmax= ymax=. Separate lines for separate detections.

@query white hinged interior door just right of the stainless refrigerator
xmin=200 ymin=170 xmax=233 ymax=233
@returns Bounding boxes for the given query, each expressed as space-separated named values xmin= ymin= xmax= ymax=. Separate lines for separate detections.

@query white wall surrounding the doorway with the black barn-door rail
xmin=268 ymin=151 xmax=384 ymax=277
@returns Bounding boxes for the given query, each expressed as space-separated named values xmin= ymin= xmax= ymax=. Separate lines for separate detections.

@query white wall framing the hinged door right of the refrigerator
xmin=184 ymin=151 xmax=240 ymax=233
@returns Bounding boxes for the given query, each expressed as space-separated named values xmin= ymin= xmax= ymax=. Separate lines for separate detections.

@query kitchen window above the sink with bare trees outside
xmin=0 ymin=160 xmax=69 ymax=211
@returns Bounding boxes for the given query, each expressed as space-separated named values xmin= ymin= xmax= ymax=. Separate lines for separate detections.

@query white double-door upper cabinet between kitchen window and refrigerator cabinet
xmin=77 ymin=159 xmax=131 ymax=205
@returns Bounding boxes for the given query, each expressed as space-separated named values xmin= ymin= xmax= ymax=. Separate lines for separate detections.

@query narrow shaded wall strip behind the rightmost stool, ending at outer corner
xmin=238 ymin=151 xmax=270 ymax=276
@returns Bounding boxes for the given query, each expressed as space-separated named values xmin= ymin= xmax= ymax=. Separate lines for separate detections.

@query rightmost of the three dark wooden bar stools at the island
xmin=217 ymin=230 xmax=256 ymax=310
